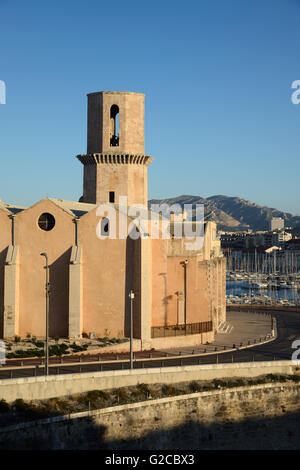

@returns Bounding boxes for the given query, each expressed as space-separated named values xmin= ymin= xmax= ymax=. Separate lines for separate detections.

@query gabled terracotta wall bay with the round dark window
xmin=15 ymin=200 xmax=75 ymax=337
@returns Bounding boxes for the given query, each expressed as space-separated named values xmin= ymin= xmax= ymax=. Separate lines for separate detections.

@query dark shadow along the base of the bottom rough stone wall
xmin=0 ymin=408 xmax=300 ymax=450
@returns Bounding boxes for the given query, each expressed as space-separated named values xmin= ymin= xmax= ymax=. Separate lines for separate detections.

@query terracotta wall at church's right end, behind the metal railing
xmin=152 ymin=224 xmax=220 ymax=326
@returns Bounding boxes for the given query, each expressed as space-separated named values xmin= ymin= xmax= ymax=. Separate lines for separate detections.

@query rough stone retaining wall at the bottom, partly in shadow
xmin=0 ymin=383 xmax=300 ymax=450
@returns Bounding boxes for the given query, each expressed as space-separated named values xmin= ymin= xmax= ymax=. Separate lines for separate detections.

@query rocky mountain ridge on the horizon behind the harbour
xmin=149 ymin=195 xmax=300 ymax=231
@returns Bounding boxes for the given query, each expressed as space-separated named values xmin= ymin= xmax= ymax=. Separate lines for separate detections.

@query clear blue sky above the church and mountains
xmin=0 ymin=0 xmax=300 ymax=215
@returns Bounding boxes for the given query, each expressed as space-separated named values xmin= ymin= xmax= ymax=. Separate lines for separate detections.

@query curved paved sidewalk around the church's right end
xmin=159 ymin=311 xmax=272 ymax=355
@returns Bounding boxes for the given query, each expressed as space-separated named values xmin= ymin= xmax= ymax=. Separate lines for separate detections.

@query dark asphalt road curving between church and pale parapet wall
xmin=0 ymin=311 xmax=300 ymax=379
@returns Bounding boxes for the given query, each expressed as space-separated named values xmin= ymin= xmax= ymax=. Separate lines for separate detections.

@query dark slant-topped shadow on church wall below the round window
xmin=49 ymin=248 xmax=72 ymax=337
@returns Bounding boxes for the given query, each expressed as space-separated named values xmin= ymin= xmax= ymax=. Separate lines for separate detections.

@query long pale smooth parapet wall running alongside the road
xmin=0 ymin=361 xmax=295 ymax=402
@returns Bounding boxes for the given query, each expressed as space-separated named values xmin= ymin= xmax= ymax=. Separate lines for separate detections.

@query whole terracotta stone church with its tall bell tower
xmin=0 ymin=91 xmax=226 ymax=349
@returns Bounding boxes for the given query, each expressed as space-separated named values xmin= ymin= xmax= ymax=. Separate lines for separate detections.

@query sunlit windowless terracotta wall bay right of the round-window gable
xmin=78 ymin=210 xmax=139 ymax=337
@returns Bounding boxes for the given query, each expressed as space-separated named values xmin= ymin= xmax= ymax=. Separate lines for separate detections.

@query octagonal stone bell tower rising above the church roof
xmin=77 ymin=91 xmax=153 ymax=206
